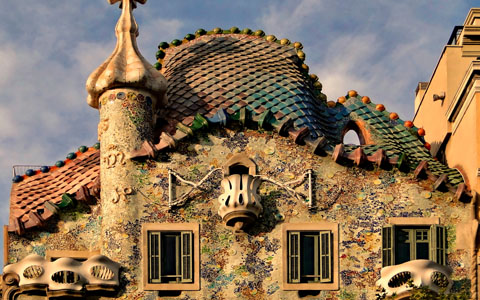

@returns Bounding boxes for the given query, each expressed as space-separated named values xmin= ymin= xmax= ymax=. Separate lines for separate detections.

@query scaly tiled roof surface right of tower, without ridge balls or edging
xmin=158 ymin=31 xmax=462 ymax=183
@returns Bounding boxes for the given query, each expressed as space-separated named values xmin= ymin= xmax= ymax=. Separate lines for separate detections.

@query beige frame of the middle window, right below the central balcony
xmin=282 ymin=222 xmax=339 ymax=291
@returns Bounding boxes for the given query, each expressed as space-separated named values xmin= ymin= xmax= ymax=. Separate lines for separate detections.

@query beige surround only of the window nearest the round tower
xmin=142 ymin=223 xmax=200 ymax=291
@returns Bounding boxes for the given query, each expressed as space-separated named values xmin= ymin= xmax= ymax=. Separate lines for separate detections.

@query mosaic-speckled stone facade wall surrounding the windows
xmin=9 ymin=129 xmax=470 ymax=300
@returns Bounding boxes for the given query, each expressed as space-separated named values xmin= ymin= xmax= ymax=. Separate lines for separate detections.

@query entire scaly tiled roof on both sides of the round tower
xmin=8 ymin=27 xmax=469 ymax=234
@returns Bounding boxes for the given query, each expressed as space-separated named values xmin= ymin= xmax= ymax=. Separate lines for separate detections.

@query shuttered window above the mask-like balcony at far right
xmin=382 ymin=218 xmax=447 ymax=267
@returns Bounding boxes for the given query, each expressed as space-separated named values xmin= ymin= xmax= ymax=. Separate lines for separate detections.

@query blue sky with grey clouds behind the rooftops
xmin=0 ymin=0 xmax=475 ymax=273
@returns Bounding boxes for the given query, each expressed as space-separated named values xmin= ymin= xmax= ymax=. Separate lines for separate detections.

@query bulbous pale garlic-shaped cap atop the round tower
xmin=86 ymin=0 xmax=167 ymax=109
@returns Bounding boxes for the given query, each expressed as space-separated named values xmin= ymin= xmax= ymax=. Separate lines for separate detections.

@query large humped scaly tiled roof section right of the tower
xmin=157 ymin=29 xmax=338 ymax=145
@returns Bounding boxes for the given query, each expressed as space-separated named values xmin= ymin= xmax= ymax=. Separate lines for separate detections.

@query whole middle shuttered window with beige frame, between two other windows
xmin=283 ymin=222 xmax=338 ymax=290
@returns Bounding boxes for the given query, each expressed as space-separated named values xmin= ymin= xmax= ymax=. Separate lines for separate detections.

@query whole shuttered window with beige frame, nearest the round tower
xmin=143 ymin=223 xmax=200 ymax=291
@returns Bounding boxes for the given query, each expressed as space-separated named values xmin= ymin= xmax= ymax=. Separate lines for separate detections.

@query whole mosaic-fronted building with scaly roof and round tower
xmin=2 ymin=0 xmax=478 ymax=299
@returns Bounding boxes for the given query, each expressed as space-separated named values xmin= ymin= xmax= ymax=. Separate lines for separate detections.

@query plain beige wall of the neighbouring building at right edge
xmin=413 ymin=8 xmax=480 ymax=190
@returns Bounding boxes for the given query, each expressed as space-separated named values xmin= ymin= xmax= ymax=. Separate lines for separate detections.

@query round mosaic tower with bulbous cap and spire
xmin=82 ymin=0 xmax=167 ymax=286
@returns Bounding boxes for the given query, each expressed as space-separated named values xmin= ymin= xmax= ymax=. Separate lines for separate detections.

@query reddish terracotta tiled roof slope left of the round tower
xmin=8 ymin=147 xmax=100 ymax=234
